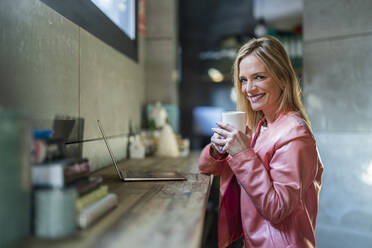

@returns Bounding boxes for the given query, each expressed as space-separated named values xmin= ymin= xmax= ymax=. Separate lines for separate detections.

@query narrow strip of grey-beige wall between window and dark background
xmin=145 ymin=0 xmax=178 ymax=104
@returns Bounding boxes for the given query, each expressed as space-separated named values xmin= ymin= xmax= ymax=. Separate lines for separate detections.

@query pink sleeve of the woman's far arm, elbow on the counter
xmin=199 ymin=144 xmax=228 ymax=175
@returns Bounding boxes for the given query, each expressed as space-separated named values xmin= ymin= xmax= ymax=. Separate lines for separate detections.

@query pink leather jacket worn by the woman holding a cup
xmin=199 ymin=112 xmax=323 ymax=248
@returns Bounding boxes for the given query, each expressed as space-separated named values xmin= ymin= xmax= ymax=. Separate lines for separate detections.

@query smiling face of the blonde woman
xmin=239 ymin=54 xmax=281 ymax=122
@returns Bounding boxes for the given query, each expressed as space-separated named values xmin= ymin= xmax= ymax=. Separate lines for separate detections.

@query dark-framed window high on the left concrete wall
xmin=41 ymin=0 xmax=138 ymax=61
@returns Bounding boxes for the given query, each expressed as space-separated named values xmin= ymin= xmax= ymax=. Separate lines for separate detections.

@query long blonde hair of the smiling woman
xmin=233 ymin=36 xmax=311 ymax=131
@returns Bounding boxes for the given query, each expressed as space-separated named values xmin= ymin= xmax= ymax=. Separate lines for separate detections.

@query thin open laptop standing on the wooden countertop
xmin=97 ymin=120 xmax=186 ymax=182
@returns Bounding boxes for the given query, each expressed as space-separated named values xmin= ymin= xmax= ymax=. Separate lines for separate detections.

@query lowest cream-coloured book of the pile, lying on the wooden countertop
xmin=77 ymin=193 xmax=118 ymax=229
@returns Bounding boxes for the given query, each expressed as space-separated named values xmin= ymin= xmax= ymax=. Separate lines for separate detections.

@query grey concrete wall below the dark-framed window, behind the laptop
xmin=0 ymin=0 xmax=146 ymax=169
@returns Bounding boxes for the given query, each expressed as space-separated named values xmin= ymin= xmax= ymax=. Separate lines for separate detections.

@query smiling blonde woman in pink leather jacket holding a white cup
xmin=199 ymin=37 xmax=323 ymax=248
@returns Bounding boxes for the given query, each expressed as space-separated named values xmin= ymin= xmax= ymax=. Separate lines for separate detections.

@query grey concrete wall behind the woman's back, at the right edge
xmin=303 ymin=0 xmax=372 ymax=248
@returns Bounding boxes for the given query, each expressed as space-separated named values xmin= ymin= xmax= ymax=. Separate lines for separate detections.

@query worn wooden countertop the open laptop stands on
xmin=21 ymin=152 xmax=212 ymax=248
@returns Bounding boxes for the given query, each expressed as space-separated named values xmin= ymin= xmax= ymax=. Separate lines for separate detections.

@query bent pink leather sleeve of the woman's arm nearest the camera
xmin=229 ymin=137 xmax=318 ymax=224
